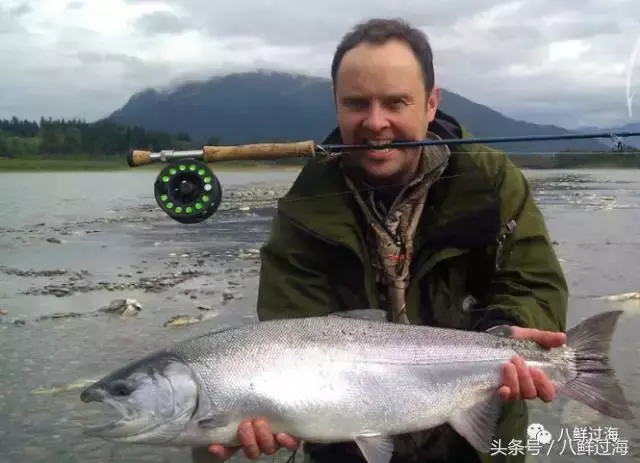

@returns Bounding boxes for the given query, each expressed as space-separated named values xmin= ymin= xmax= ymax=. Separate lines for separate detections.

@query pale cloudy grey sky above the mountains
xmin=0 ymin=0 xmax=640 ymax=128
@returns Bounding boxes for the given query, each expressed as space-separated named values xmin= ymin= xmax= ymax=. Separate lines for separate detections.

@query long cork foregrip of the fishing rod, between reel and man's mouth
xmin=202 ymin=140 xmax=316 ymax=162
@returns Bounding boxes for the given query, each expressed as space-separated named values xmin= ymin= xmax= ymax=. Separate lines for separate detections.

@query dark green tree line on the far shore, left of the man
xmin=0 ymin=117 xmax=219 ymax=158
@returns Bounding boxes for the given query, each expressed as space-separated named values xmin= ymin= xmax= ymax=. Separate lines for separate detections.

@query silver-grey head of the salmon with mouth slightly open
xmin=80 ymin=353 xmax=198 ymax=444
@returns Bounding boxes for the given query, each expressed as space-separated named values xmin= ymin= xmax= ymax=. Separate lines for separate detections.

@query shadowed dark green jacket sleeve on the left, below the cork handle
xmin=257 ymin=212 xmax=334 ymax=321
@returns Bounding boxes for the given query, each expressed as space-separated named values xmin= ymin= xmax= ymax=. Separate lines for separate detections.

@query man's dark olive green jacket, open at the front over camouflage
xmin=257 ymin=111 xmax=568 ymax=463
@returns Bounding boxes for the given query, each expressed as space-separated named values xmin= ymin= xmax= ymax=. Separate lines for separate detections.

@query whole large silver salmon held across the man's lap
xmin=81 ymin=311 xmax=633 ymax=463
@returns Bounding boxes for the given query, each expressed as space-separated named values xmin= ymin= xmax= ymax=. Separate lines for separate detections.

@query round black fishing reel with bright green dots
xmin=153 ymin=158 xmax=222 ymax=224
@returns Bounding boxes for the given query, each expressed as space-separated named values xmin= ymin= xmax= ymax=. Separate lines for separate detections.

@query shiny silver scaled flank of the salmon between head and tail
xmin=171 ymin=317 xmax=516 ymax=442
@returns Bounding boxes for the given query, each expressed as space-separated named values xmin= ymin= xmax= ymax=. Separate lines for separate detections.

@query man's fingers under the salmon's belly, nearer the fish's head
xmin=209 ymin=418 xmax=300 ymax=460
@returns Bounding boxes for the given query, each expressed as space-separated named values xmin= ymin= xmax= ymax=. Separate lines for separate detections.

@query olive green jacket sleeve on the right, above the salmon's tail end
xmin=475 ymin=154 xmax=568 ymax=331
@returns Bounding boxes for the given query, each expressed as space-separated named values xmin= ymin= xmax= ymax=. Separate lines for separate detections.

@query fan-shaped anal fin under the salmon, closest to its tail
xmin=449 ymin=394 xmax=502 ymax=453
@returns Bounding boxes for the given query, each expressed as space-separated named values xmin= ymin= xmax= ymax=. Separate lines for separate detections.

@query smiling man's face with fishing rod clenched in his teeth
xmin=335 ymin=40 xmax=440 ymax=185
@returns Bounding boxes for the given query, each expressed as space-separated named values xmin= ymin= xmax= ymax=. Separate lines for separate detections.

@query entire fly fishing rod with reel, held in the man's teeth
xmin=127 ymin=132 xmax=640 ymax=224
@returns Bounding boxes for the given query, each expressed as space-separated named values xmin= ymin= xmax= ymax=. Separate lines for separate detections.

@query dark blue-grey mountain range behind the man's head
xmin=107 ymin=71 xmax=607 ymax=154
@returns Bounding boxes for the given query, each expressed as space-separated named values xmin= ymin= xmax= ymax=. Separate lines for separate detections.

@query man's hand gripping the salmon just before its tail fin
xmin=498 ymin=326 xmax=567 ymax=402
